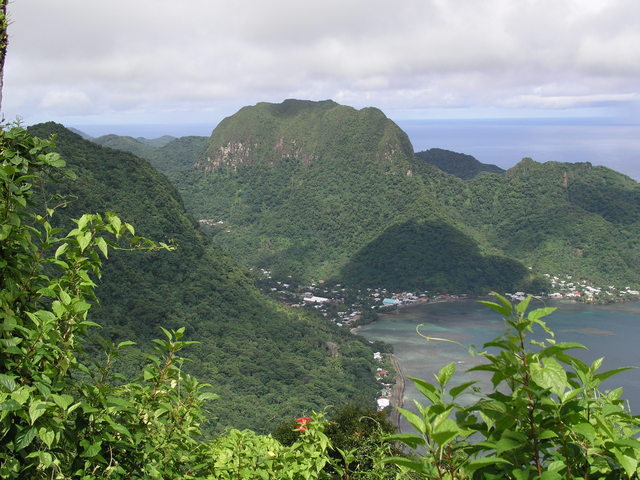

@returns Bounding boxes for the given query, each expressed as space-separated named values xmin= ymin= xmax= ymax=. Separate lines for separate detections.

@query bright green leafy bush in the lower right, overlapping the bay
xmin=391 ymin=295 xmax=640 ymax=480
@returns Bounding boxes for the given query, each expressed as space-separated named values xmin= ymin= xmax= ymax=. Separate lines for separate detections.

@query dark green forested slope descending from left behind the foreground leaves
xmin=30 ymin=123 xmax=377 ymax=431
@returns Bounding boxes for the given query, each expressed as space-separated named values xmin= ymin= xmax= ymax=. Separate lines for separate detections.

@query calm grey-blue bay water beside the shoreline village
xmin=359 ymin=301 xmax=640 ymax=432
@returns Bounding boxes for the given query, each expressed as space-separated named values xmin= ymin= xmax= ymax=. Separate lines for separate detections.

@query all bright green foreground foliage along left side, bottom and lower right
xmin=0 ymin=125 xmax=640 ymax=480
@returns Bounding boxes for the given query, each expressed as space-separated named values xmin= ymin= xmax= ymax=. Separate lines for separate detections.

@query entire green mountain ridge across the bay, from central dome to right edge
xmin=84 ymin=100 xmax=640 ymax=293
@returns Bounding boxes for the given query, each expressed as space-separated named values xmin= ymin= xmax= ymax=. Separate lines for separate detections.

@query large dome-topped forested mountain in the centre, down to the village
xmin=170 ymin=100 xmax=527 ymax=291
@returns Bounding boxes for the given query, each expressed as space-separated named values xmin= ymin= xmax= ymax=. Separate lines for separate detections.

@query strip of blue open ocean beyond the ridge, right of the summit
xmin=396 ymin=119 xmax=640 ymax=180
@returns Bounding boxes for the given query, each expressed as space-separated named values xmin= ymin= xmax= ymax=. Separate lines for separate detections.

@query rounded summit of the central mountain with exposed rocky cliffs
xmin=196 ymin=100 xmax=413 ymax=171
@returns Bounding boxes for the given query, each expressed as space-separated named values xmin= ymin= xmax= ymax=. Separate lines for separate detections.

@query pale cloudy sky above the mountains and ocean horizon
xmin=2 ymin=0 xmax=640 ymax=178
